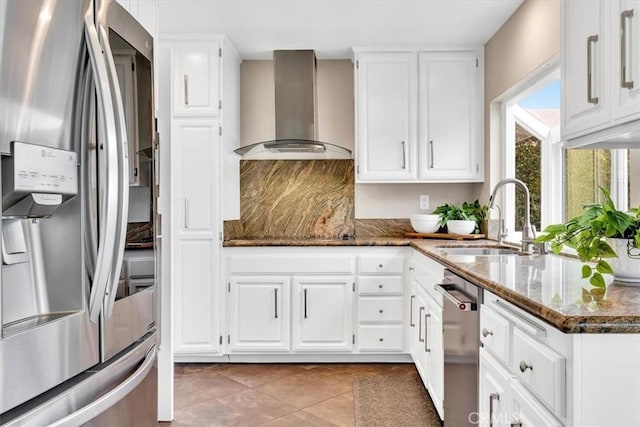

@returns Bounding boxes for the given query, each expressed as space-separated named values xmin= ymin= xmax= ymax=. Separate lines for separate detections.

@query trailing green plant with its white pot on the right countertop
xmin=536 ymin=188 xmax=640 ymax=288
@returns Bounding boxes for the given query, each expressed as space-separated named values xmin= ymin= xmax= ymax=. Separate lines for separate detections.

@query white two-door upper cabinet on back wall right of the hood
xmin=355 ymin=50 xmax=484 ymax=183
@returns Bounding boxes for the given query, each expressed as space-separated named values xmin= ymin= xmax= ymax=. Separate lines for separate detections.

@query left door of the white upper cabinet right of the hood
xmin=356 ymin=52 xmax=417 ymax=182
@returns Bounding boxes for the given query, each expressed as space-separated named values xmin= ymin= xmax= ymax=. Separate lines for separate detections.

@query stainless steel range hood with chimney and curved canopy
xmin=235 ymin=50 xmax=351 ymax=159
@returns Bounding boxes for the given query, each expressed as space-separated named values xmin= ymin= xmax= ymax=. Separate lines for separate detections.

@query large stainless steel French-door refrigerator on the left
xmin=0 ymin=0 xmax=159 ymax=426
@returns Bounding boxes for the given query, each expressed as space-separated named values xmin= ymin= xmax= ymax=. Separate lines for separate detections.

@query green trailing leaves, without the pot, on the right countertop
xmin=536 ymin=187 xmax=640 ymax=288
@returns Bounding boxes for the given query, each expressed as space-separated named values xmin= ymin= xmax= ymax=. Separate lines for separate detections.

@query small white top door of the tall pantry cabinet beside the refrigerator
xmin=171 ymin=41 xmax=220 ymax=117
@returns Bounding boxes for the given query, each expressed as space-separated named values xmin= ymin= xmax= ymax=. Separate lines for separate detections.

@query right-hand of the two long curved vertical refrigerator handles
xmin=99 ymin=25 xmax=129 ymax=319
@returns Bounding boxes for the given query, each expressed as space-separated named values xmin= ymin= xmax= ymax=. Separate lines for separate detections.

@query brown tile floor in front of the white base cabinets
xmin=160 ymin=364 xmax=415 ymax=427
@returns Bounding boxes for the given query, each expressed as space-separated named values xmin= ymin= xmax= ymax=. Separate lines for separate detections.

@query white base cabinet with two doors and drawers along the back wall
xmin=224 ymin=247 xmax=408 ymax=360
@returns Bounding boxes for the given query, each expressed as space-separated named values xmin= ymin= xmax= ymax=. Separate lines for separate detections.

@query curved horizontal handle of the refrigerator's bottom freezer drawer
xmin=49 ymin=345 xmax=156 ymax=427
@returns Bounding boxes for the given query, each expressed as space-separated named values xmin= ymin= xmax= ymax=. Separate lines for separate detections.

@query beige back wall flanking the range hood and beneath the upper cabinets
xmin=240 ymin=60 xmax=479 ymax=218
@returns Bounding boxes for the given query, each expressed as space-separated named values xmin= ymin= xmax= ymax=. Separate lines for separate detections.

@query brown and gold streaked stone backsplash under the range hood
xmin=236 ymin=160 xmax=355 ymax=239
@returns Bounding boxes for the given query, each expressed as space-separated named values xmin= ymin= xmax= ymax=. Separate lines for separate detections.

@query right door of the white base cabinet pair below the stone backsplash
xmin=293 ymin=277 xmax=353 ymax=351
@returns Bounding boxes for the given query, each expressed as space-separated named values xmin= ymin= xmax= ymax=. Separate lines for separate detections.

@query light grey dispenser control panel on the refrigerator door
xmin=13 ymin=141 xmax=78 ymax=195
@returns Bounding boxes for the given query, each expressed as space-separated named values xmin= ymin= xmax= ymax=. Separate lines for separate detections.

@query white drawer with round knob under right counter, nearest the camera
xmin=511 ymin=328 xmax=566 ymax=416
